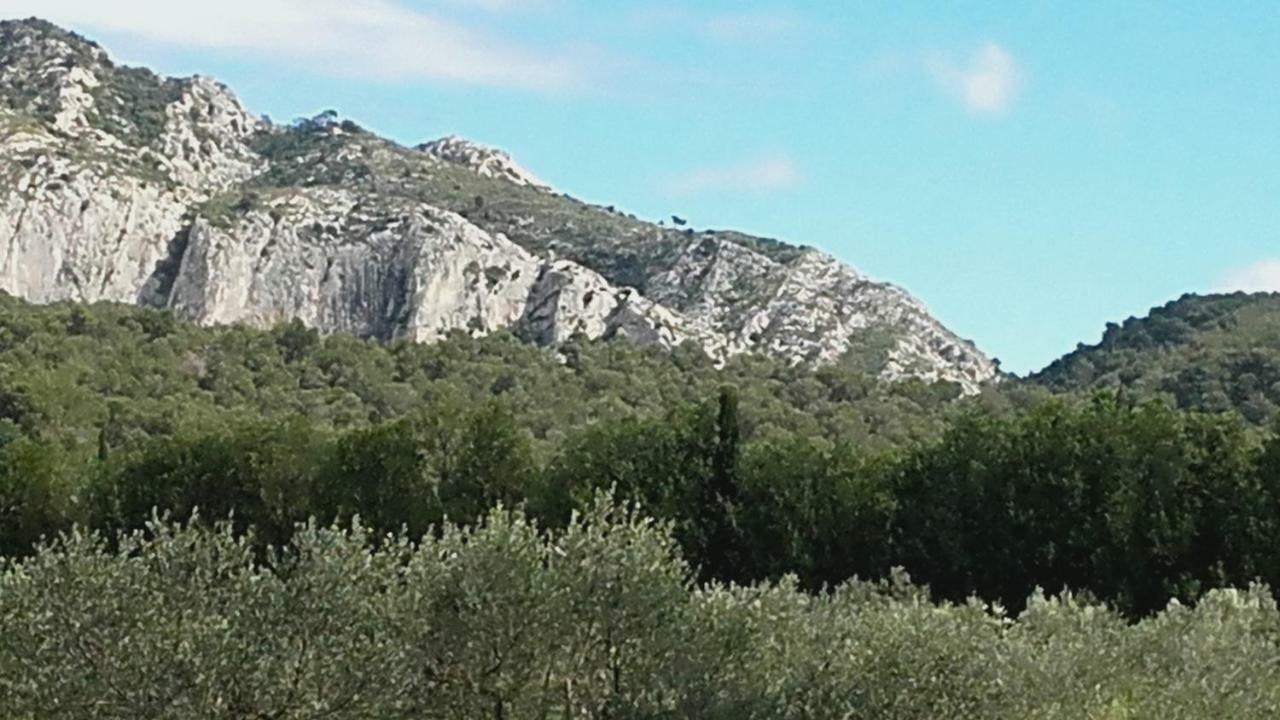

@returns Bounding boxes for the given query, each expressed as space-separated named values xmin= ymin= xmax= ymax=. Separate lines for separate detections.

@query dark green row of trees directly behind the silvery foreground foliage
xmin=10 ymin=388 xmax=1280 ymax=616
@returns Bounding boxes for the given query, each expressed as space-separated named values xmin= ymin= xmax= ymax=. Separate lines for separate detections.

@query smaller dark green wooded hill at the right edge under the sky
xmin=1028 ymin=293 xmax=1280 ymax=423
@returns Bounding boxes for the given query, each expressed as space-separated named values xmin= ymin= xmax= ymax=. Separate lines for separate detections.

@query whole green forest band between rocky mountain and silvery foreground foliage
xmin=0 ymin=294 xmax=1280 ymax=607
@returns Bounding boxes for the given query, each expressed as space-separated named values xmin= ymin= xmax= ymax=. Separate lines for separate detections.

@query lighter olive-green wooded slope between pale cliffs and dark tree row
xmin=0 ymin=293 xmax=959 ymax=450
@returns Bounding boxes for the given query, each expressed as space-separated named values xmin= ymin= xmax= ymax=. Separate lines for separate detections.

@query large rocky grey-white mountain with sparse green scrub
xmin=0 ymin=20 xmax=997 ymax=392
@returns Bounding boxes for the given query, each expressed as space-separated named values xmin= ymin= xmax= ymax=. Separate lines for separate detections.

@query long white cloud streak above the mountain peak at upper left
xmin=0 ymin=0 xmax=582 ymax=91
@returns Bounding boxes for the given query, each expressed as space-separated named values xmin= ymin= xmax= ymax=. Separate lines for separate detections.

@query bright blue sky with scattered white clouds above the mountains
xmin=0 ymin=0 xmax=1280 ymax=373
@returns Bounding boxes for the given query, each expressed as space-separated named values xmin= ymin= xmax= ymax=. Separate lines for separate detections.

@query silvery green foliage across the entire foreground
xmin=0 ymin=501 xmax=1280 ymax=720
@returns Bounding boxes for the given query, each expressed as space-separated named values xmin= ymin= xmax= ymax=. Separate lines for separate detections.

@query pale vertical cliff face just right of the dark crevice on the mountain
xmin=169 ymin=188 xmax=539 ymax=342
